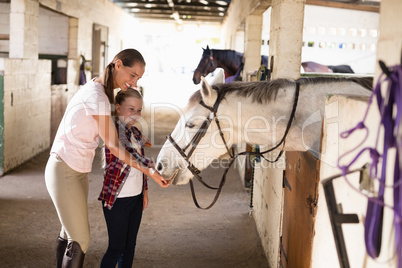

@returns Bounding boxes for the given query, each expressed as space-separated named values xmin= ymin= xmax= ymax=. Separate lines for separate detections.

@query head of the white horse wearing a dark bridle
xmin=156 ymin=75 xmax=232 ymax=185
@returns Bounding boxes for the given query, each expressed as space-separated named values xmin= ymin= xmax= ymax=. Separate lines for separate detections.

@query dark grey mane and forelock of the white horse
xmin=189 ymin=76 xmax=373 ymax=106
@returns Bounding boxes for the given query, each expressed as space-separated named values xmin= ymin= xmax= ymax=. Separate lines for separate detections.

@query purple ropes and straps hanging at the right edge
xmin=338 ymin=61 xmax=402 ymax=268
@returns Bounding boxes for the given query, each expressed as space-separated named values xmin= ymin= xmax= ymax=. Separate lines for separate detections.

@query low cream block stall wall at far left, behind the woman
xmin=1 ymin=59 xmax=51 ymax=172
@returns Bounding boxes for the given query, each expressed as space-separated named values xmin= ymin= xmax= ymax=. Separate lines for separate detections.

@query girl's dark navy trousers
xmin=100 ymin=194 xmax=143 ymax=268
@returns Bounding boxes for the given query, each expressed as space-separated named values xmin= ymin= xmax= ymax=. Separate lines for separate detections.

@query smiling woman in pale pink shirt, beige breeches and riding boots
xmin=45 ymin=49 xmax=169 ymax=268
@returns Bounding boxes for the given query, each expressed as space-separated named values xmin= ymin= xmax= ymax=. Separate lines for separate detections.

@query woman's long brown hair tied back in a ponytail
xmin=103 ymin=48 xmax=145 ymax=104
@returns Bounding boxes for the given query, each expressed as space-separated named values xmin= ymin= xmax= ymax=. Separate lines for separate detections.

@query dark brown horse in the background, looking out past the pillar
xmin=193 ymin=46 xmax=268 ymax=84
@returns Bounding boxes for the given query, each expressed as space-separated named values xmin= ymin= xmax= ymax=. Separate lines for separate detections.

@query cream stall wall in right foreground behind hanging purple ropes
xmin=312 ymin=93 xmax=397 ymax=267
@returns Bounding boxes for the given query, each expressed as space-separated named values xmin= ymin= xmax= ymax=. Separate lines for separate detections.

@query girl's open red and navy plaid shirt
xmin=98 ymin=116 xmax=152 ymax=209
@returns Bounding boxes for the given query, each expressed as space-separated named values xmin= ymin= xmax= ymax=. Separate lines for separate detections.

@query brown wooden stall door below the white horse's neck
xmin=280 ymin=152 xmax=319 ymax=268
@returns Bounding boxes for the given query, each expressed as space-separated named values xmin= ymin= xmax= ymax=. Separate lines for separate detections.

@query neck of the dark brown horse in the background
xmin=212 ymin=49 xmax=243 ymax=76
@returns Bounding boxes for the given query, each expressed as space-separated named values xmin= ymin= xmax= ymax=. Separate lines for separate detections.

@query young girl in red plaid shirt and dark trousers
xmin=99 ymin=88 xmax=150 ymax=268
